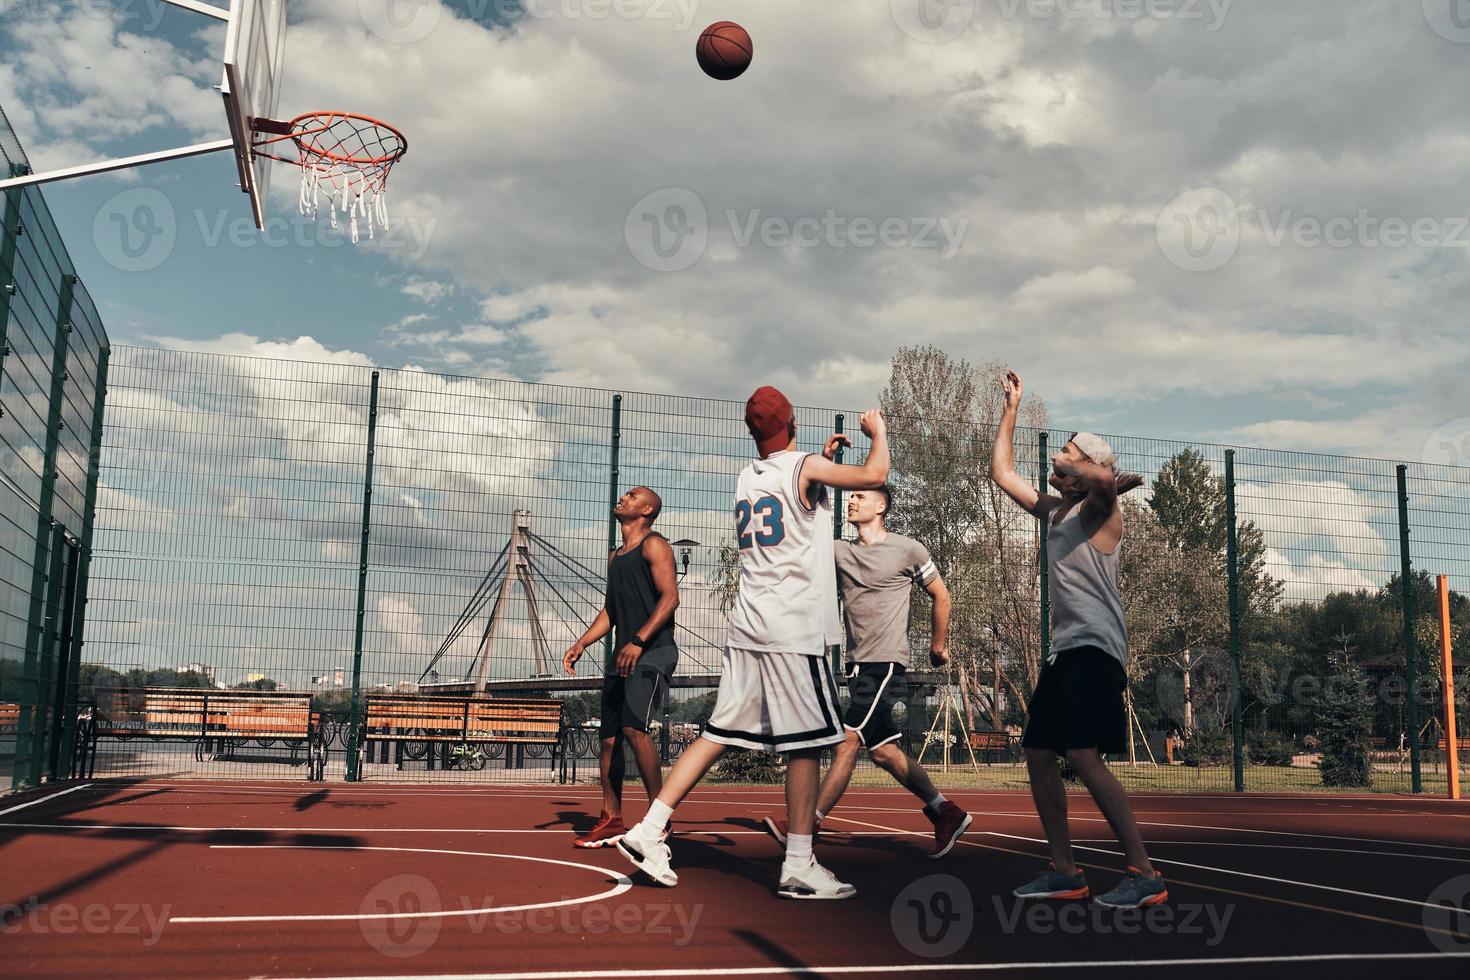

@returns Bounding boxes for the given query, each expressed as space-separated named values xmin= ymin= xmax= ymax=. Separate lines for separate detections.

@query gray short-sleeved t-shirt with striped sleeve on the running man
xmin=833 ymin=533 xmax=939 ymax=667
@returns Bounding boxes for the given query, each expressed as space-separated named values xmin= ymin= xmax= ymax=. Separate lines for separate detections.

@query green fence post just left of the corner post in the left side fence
xmin=10 ymin=273 xmax=76 ymax=789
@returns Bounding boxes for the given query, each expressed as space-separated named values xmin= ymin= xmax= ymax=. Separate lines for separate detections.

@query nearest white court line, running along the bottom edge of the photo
xmin=258 ymin=952 xmax=1470 ymax=980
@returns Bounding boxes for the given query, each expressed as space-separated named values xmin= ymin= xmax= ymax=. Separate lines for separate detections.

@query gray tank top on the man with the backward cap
xmin=1047 ymin=504 xmax=1127 ymax=667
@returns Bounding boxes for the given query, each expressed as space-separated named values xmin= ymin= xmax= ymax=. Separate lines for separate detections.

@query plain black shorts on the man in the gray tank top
xmin=1020 ymin=646 xmax=1127 ymax=755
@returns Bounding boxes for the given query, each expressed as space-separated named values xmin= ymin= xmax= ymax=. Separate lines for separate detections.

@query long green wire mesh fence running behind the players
xmin=71 ymin=348 xmax=1470 ymax=792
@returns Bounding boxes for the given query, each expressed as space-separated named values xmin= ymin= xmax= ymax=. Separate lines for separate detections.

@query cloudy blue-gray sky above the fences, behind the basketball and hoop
xmin=0 ymin=0 xmax=1470 ymax=464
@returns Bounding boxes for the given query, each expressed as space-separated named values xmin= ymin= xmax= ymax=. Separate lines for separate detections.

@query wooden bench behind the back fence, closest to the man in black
xmin=357 ymin=693 xmax=564 ymax=777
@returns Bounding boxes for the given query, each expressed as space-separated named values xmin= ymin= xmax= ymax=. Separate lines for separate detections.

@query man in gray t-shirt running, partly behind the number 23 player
xmin=764 ymin=486 xmax=970 ymax=858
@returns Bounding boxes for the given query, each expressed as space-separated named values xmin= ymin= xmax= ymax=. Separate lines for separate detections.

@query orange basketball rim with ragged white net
xmin=254 ymin=112 xmax=409 ymax=242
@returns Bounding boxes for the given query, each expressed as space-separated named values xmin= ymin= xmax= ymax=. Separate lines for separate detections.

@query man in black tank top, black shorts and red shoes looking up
xmin=562 ymin=486 xmax=679 ymax=848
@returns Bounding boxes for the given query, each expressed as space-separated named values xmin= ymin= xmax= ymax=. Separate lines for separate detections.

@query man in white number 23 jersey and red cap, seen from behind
xmin=617 ymin=388 xmax=888 ymax=899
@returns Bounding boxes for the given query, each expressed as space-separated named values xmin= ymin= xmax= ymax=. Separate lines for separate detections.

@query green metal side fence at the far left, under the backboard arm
xmin=0 ymin=103 xmax=109 ymax=788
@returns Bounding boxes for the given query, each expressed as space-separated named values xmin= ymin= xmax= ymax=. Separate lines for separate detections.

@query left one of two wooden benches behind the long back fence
xmin=74 ymin=688 xmax=325 ymax=780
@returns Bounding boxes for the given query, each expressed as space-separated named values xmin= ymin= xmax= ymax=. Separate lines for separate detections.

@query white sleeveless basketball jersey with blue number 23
xmin=729 ymin=450 xmax=842 ymax=657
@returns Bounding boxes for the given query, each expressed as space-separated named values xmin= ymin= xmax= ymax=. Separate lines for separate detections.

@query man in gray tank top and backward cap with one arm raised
xmin=991 ymin=372 xmax=1169 ymax=908
